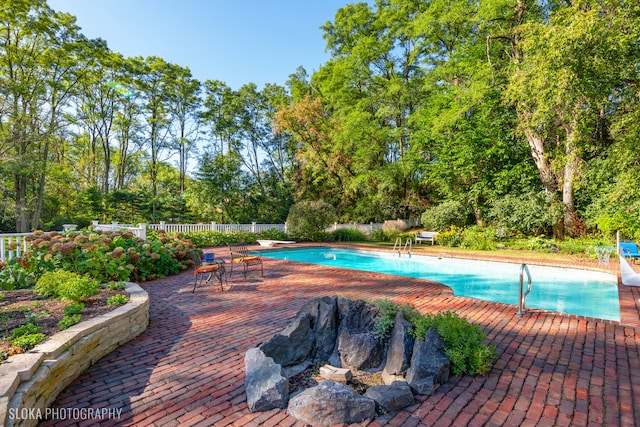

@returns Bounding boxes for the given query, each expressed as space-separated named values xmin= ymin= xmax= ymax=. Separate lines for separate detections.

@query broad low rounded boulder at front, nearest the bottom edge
xmin=287 ymin=380 xmax=375 ymax=426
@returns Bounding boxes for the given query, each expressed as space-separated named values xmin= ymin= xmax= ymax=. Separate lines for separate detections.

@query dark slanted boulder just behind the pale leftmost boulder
xmin=260 ymin=312 xmax=314 ymax=366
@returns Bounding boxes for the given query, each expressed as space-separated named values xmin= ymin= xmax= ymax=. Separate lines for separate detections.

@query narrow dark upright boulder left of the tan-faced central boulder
xmin=300 ymin=296 xmax=340 ymax=362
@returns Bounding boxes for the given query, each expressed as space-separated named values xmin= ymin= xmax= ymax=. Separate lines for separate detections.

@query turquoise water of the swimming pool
xmin=262 ymin=248 xmax=620 ymax=321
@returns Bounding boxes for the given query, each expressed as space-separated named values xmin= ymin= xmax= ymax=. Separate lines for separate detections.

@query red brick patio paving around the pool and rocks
xmin=41 ymin=248 xmax=640 ymax=426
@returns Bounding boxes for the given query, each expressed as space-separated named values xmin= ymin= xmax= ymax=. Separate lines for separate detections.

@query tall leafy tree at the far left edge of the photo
xmin=0 ymin=0 xmax=99 ymax=232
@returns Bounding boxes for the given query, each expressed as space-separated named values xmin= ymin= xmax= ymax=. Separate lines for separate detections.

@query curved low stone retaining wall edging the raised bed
xmin=0 ymin=282 xmax=149 ymax=427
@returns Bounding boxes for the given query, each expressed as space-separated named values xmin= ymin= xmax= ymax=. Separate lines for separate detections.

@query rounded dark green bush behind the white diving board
xmin=287 ymin=200 xmax=336 ymax=241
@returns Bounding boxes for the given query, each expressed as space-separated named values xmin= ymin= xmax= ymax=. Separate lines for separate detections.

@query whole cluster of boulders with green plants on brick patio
xmin=245 ymin=297 xmax=496 ymax=425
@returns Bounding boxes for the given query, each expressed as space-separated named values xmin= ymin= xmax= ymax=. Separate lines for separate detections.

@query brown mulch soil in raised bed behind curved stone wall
xmin=0 ymin=289 xmax=126 ymax=363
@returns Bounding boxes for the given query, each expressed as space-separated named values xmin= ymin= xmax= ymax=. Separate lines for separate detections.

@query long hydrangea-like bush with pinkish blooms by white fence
xmin=0 ymin=230 xmax=195 ymax=289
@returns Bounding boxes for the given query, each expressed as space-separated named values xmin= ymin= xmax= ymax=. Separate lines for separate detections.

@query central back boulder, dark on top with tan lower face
xmin=338 ymin=300 xmax=386 ymax=370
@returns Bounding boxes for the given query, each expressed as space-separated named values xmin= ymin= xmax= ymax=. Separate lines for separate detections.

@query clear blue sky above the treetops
xmin=48 ymin=0 xmax=356 ymax=89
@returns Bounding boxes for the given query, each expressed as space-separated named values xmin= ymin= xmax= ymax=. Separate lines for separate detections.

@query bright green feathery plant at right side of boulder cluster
xmin=414 ymin=311 xmax=497 ymax=375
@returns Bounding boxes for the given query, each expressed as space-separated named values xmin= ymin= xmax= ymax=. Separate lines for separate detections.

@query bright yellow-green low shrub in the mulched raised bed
xmin=35 ymin=270 xmax=99 ymax=302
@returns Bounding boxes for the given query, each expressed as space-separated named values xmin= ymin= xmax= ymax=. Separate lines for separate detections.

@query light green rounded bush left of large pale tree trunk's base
xmin=488 ymin=192 xmax=563 ymax=234
